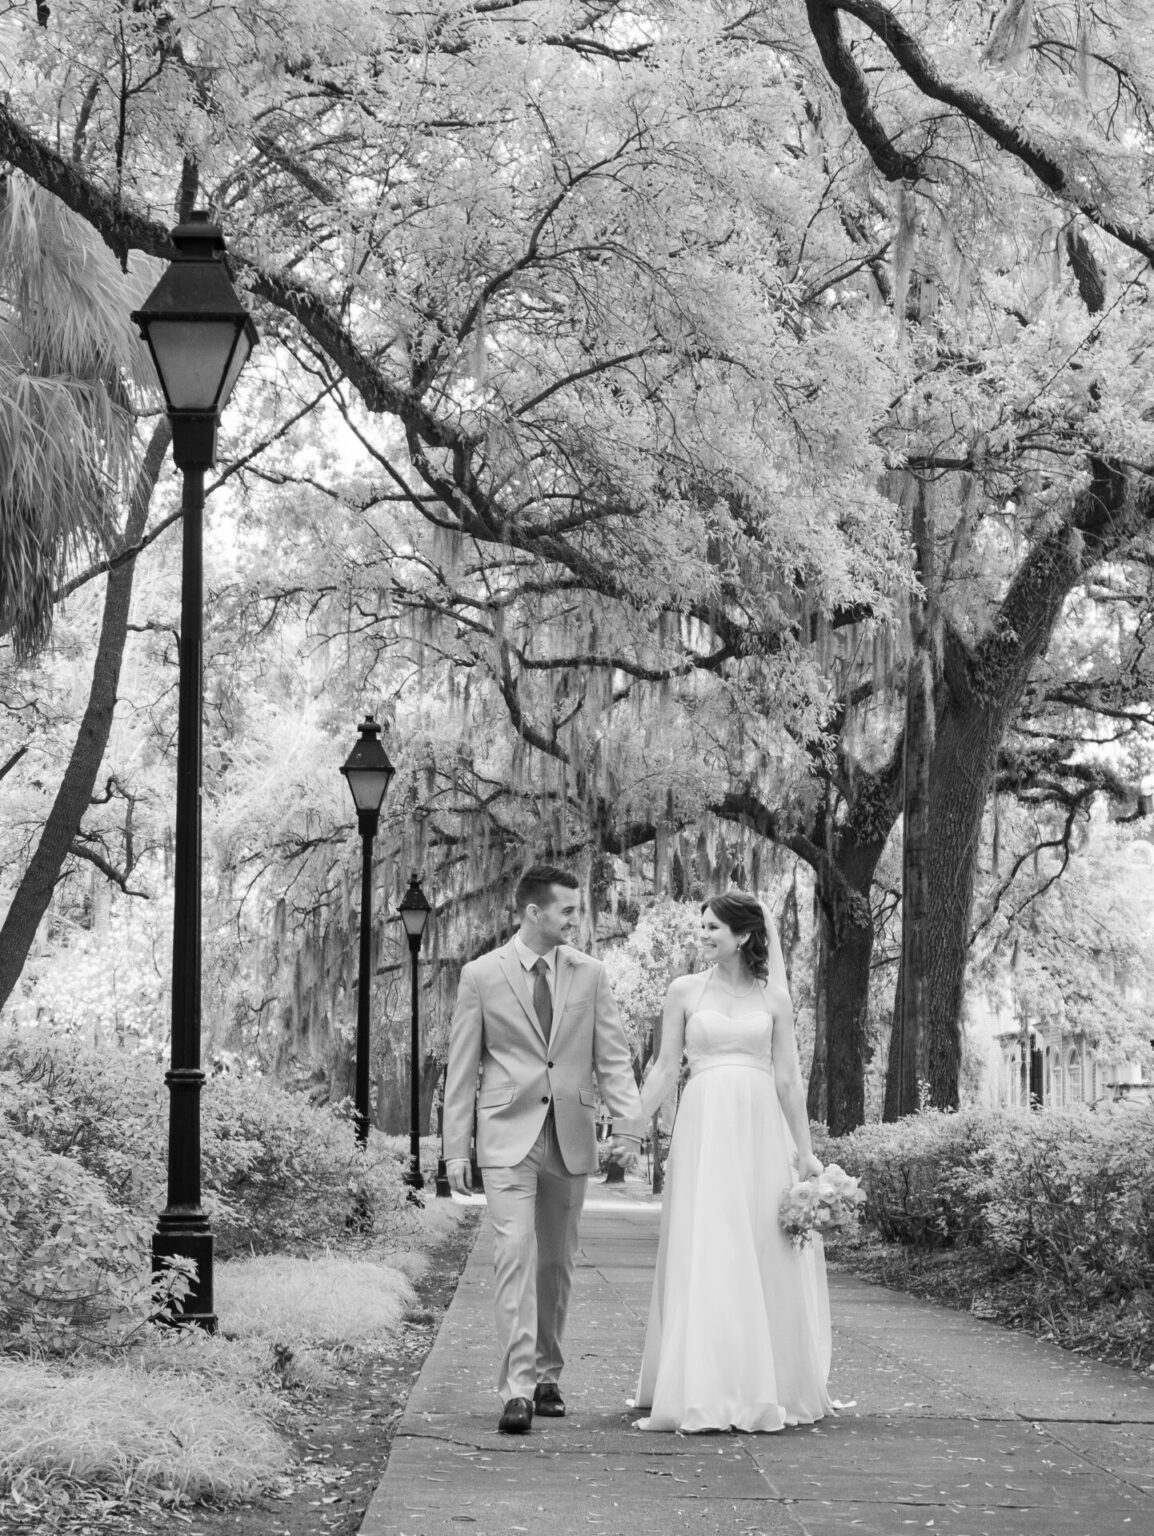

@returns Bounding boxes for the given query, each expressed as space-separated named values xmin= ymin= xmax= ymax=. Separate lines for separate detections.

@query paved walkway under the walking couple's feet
xmin=361 ymin=1184 xmax=1154 ymax=1536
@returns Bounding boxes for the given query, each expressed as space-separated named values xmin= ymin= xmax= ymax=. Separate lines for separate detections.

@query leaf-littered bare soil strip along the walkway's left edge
xmin=0 ymin=1212 xmax=476 ymax=1536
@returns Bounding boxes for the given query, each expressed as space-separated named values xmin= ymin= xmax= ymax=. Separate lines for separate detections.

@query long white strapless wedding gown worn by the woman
xmin=636 ymin=1008 xmax=833 ymax=1433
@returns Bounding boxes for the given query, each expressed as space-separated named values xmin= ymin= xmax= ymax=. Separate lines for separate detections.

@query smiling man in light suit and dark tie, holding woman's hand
xmin=443 ymin=865 xmax=641 ymax=1435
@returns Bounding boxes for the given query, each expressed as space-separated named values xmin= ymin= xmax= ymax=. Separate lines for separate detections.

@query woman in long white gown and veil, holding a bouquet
xmin=632 ymin=891 xmax=833 ymax=1433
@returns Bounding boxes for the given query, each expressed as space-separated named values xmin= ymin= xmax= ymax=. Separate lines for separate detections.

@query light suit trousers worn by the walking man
xmin=484 ymin=1104 xmax=589 ymax=1402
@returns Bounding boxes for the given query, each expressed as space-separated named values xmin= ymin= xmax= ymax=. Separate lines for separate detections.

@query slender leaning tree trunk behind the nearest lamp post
xmin=0 ymin=419 xmax=172 ymax=1008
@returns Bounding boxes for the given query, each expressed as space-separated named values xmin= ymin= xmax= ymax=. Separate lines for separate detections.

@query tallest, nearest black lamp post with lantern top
xmin=132 ymin=212 xmax=257 ymax=1332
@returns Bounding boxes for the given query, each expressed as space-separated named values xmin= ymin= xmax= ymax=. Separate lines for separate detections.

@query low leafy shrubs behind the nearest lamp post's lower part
xmin=0 ymin=1031 xmax=421 ymax=1347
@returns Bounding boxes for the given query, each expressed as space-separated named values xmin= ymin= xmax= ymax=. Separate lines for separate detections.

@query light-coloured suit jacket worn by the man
xmin=443 ymin=940 xmax=641 ymax=1174
